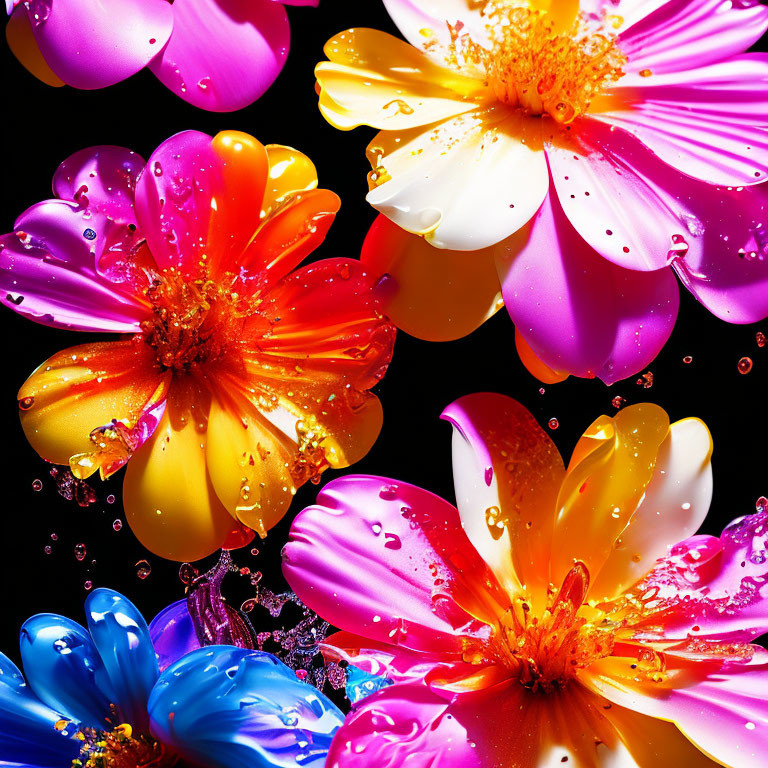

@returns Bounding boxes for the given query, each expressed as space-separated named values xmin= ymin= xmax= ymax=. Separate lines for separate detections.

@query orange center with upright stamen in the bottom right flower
xmin=502 ymin=563 xmax=614 ymax=692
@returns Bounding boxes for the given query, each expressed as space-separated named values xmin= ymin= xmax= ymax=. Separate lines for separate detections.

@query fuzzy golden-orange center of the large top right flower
xmin=449 ymin=0 xmax=627 ymax=123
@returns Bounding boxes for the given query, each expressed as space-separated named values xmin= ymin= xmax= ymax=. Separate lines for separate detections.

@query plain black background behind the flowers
xmin=0 ymin=0 xmax=768 ymax=659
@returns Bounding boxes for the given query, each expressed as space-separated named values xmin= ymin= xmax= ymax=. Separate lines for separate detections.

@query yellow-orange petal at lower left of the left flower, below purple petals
xmin=18 ymin=339 xmax=162 ymax=464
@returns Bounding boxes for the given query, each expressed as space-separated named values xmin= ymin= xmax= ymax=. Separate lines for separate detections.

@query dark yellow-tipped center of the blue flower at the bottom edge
xmin=72 ymin=724 xmax=179 ymax=768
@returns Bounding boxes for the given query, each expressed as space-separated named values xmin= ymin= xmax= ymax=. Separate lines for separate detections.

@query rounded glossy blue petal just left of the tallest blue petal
xmin=21 ymin=613 xmax=116 ymax=728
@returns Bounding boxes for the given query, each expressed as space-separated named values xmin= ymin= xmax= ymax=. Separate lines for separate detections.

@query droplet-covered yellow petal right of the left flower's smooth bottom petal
xmin=206 ymin=399 xmax=296 ymax=536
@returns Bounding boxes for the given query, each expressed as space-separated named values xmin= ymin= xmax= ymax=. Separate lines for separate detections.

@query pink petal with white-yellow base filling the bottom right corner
xmin=588 ymin=662 xmax=768 ymax=768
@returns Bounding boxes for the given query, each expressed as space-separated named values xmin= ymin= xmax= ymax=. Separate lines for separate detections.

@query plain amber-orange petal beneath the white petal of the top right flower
xmin=361 ymin=215 xmax=503 ymax=341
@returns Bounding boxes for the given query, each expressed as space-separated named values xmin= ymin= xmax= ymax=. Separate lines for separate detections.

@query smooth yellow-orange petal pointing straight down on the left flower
xmin=123 ymin=381 xmax=233 ymax=562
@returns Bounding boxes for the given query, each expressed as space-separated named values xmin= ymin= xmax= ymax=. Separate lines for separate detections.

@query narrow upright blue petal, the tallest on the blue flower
xmin=85 ymin=589 xmax=160 ymax=733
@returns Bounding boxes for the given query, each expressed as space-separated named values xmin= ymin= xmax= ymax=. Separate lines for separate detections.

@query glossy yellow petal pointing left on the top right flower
xmin=315 ymin=29 xmax=492 ymax=130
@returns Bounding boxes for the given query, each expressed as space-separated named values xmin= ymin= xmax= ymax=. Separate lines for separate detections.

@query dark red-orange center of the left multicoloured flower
xmin=142 ymin=270 xmax=247 ymax=372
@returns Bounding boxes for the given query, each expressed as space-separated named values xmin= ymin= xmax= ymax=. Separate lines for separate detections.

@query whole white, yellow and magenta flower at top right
xmin=316 ymin=0 xmax=768 ymax=383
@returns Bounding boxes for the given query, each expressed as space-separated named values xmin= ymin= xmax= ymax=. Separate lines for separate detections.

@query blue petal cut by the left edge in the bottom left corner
xmin=0 ymin=653 xmax=80 ymax=768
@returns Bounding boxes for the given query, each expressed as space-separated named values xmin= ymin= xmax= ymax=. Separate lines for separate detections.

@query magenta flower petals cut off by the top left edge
xmin=6 ymin=0 xmax=319 ymax=112
